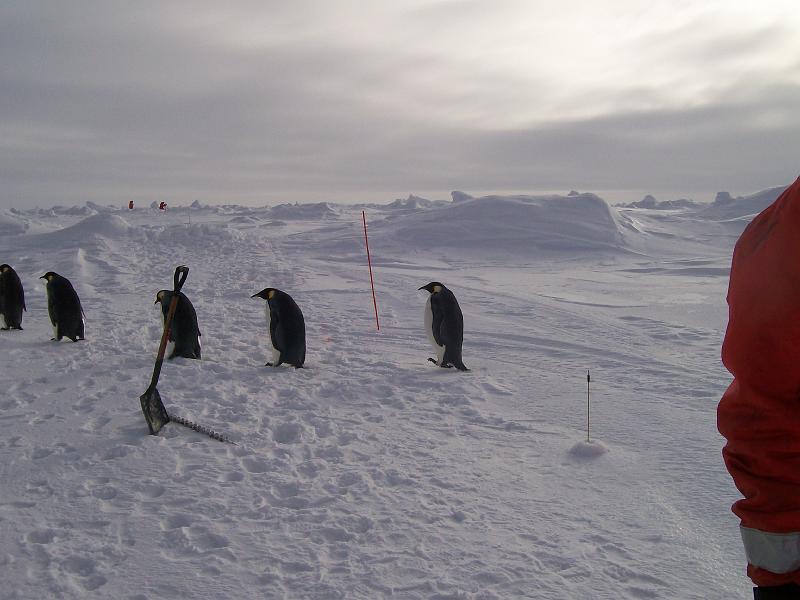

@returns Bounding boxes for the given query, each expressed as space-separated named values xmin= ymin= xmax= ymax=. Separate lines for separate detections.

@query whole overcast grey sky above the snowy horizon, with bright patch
xmin=0 ymin=0 xmax=800 ymax=207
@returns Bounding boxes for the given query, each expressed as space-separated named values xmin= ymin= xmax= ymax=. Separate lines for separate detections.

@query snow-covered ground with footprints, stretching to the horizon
xmin=0 ymin=186 xmax=777 ymax=600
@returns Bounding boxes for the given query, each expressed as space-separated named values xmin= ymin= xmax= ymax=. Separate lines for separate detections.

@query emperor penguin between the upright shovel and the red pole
xmin=250 ymin=288 xmax=306 ymax=369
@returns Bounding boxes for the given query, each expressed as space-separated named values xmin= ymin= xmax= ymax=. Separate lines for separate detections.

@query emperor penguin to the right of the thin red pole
xmin=419 ymin=281 xmax=469 ymax=371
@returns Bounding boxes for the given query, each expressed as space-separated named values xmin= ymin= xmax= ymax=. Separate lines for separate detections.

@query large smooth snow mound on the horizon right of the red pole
xmin=378 ymin=194 xmax=627 ymax=254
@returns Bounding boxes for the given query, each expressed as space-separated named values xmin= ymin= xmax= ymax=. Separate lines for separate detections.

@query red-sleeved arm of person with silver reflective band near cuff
xmin=717 ymin=179 xmax=800 ymax=600
